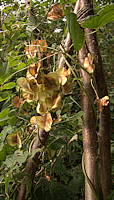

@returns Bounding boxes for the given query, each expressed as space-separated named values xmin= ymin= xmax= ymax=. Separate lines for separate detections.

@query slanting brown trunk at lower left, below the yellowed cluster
xmin=17 ymin=129 xmax=48 ymax=200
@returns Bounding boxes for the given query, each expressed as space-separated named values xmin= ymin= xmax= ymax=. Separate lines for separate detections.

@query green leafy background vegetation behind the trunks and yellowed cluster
xmin=0 ymin=0 xmax=114 ymax=200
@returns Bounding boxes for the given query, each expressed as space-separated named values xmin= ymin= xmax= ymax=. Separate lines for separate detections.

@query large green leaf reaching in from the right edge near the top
xmin=81 ymin=4 xmax=114 ymax=29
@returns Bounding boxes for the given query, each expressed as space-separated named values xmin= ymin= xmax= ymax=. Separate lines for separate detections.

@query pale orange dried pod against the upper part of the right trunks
xmin=83 ymin=53 xmax=94 ymax=73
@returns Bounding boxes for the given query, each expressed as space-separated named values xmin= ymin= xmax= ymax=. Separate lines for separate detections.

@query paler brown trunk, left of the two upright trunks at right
xmin=79 ymin=47 xmax=98 ymax=200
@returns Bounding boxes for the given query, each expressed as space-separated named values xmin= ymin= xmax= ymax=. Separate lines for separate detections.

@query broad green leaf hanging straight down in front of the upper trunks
xmin=67 ymin=13 xmax=84 ymax=51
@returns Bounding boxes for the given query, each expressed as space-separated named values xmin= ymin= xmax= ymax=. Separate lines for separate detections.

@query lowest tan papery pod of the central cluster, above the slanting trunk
xmin=30 ymin=112 xmax=53 ymax=132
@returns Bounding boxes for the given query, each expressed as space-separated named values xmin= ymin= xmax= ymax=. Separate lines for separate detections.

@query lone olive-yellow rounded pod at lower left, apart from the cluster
xmin=6 ymin=133 xmax=22 ymax=148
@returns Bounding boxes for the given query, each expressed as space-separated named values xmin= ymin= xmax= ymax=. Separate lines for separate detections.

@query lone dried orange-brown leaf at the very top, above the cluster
xmin=47 ymin=3 xmax=64 ymax=20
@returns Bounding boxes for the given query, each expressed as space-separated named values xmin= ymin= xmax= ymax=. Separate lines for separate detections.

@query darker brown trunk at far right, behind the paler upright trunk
xmin=81 ymin=0 xmax=111 ymax=200
